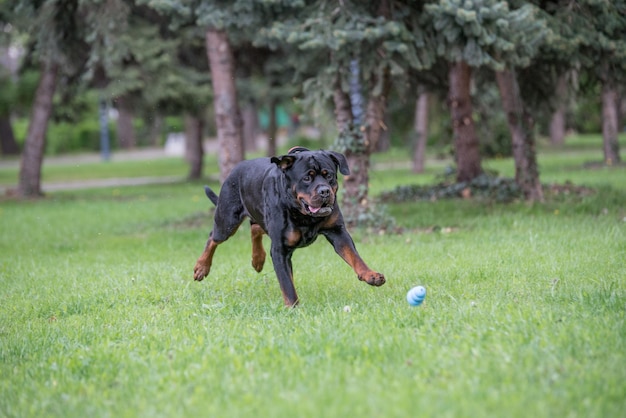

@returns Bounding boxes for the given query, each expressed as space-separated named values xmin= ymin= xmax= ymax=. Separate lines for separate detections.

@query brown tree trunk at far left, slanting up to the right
xmin=18 ymin=62 xmax=59 ymax=197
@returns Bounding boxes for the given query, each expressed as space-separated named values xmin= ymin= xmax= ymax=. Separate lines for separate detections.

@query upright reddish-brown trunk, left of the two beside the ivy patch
xmin=449 ymin=61 xmax=483 ymax=182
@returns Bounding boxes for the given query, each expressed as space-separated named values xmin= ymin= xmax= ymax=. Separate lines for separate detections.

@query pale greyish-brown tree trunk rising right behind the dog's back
xmin=206 ymin=29 xmax=244 ymax=183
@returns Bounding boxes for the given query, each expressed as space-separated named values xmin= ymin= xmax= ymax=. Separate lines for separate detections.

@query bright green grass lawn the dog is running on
xmin=0 ymin=136 xmax=626 ymax=417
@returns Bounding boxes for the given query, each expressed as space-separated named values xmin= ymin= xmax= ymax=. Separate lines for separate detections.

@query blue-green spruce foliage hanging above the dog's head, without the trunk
xmin=255 ymin=1 xmax=435 ymax=119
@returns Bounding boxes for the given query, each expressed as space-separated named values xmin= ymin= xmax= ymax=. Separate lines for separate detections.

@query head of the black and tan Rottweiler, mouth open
xmin=272 ymin=147 xmax=350 ymax=217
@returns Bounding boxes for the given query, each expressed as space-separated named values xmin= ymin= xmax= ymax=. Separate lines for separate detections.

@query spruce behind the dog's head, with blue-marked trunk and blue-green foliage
xmin=260 ymin=0 xmax=432 ymax=223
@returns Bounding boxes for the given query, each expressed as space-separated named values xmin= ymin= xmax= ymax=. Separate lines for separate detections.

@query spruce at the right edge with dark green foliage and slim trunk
xmin=530 ymin=0 xmax=626 ymax=165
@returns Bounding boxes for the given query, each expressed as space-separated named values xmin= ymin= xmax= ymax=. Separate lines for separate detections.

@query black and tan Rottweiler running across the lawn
xmin=194 ymin=147 xmax=385 ymax=307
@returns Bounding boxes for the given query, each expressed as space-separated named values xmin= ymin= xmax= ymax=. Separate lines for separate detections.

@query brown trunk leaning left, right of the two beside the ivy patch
xmin=496 ymin=70 xmax=543 ymax=202
